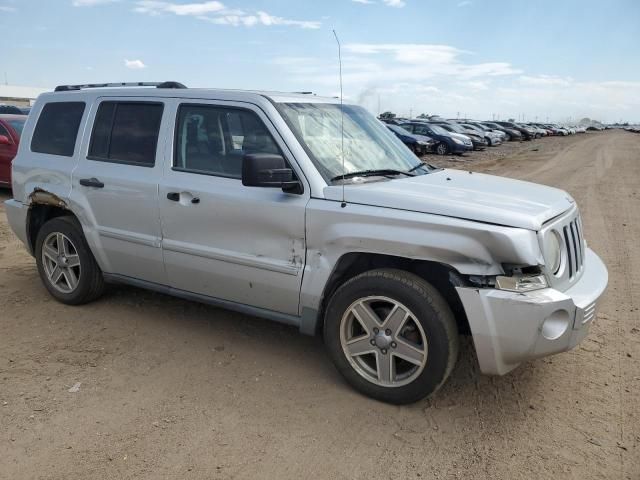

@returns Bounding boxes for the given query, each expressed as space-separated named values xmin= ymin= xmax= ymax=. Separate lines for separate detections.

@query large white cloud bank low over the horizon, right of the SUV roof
xmin=273 ymin=43 xmax=640 ymax=122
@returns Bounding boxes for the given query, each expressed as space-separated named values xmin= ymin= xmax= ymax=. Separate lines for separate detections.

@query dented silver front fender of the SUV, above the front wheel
xmin=300 ymin=199 xmax=544 ymax=314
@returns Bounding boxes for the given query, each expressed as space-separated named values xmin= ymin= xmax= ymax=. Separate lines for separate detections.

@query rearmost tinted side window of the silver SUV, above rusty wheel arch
xmin=31 ymin=102 xmax=85 ymax=157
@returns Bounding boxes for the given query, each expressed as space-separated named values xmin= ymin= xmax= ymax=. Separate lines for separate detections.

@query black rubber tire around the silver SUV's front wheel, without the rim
xmin=324 ymin=269 xmax=459 ymax=405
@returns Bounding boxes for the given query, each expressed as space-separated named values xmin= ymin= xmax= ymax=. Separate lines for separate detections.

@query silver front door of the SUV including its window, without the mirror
xmin=159 ymin=101 xmax=309 ymax=315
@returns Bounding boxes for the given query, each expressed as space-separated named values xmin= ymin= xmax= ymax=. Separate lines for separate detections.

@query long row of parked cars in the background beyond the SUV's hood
xmin=379 ymin=116 xmax=587 ymax=156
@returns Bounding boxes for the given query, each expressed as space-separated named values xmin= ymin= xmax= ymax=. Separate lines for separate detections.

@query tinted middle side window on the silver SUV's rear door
xmin=89 ymin=102 xmax=164 ymax=167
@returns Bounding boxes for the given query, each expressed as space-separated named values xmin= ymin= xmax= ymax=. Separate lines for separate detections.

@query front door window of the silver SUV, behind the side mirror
xmin=173 ymin=104 xmax=281 ymax=178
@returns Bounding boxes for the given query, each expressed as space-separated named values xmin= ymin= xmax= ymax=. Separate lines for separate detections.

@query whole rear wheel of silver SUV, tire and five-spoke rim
xmin=35 ymin=217 xmax=104 ymax=305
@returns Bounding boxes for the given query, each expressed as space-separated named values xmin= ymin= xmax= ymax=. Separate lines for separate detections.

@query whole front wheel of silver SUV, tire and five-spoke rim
xmin=324 ymin=269 xmax=459 ymax=404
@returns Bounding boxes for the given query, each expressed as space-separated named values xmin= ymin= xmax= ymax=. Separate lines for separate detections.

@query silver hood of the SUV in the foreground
xmin=324 ymin=170 xmax=574 ymax=231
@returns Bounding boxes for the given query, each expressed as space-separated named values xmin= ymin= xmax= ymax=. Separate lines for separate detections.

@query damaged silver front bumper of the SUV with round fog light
xmin=456 ymin=248 xmax=608 ymax=375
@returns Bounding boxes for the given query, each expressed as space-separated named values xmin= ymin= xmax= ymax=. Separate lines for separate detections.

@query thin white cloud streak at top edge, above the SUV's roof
xmin=134 ymin=0 xmax=321 ymax=29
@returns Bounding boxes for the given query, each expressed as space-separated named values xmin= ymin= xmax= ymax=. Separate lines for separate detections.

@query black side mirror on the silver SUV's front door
xmin=242 ymin=153 xmax=302 ymax=193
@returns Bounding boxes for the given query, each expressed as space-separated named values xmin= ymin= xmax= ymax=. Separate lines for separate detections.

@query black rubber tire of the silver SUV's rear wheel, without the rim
xmin=35 ymin=216 xmax=105 ymax=305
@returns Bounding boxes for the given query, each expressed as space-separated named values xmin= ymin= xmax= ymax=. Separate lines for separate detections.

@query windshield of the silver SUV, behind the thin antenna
xmin=278 ymin=103 xmax=431 ymax=182
